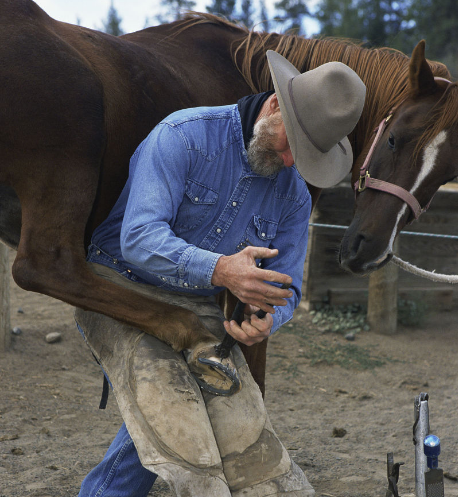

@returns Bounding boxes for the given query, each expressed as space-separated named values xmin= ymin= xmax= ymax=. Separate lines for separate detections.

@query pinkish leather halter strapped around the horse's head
xmin=354 ymin=77 xmax=451 ymax=219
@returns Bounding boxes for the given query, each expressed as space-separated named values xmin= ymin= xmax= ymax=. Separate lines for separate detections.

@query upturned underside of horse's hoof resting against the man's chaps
xmin=186 ymin=345 xmax=241 ymax=396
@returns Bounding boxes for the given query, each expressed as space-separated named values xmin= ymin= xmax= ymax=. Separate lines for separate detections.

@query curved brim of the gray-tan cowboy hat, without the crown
xmin=267 ymin=50 xmax=353 ymax=188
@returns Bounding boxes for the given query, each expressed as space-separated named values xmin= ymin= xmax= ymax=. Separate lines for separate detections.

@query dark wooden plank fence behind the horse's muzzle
xmin=303 ymin=183 xmax=458 ymax=332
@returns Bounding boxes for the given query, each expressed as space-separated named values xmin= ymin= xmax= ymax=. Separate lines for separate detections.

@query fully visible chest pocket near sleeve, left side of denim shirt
xmin=174 ymin=179 xmax=218 ymax=231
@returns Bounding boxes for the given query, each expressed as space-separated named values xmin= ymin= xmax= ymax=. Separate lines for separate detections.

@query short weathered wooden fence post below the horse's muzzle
xmin=367 ymin=240 xmax=399 ymax=335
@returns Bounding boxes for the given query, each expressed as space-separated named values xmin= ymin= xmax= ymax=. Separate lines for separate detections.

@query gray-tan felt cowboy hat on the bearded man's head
xmin=267 ymin=50 xmax=366 ymax=188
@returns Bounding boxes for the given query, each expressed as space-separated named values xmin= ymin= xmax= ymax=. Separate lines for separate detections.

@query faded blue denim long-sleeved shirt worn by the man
xmin=92 ymin=105 xmax=311 ymax=331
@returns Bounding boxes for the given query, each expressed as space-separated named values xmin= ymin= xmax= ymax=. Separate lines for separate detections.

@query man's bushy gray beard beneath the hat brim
xmin=248 ymin=117 xmax=285 ymax=176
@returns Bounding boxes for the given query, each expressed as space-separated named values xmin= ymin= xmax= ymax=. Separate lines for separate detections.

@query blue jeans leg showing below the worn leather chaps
xmin=78 ymin=423 xmax=157 ymax=497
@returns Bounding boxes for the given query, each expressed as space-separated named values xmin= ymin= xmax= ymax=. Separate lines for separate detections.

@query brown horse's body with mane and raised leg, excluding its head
xmin=0 ymin=0 xmax=449 ymax=394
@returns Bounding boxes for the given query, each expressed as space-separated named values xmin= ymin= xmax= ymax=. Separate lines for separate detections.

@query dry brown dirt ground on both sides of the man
xmin=0 ymin=262 xmax=458 ymax=497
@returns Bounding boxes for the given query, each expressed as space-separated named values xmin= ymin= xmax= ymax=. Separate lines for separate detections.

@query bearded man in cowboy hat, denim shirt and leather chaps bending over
xmin=77 ymin=51 xmax=365 ymax=497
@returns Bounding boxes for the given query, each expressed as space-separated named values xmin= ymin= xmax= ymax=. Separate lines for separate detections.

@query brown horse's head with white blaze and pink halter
xmin=340 ymin=41 xmax=458 ymax=274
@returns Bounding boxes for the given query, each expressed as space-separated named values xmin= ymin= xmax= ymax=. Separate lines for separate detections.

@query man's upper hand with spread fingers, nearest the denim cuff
xmin=212 ymin=246 xmax=293 ymax=312
